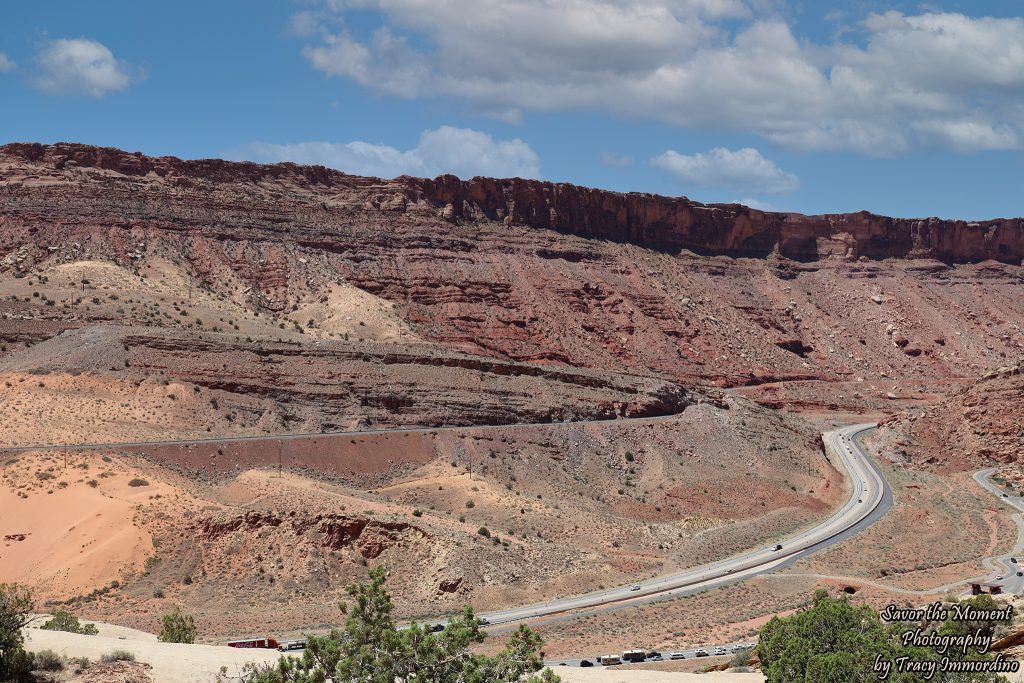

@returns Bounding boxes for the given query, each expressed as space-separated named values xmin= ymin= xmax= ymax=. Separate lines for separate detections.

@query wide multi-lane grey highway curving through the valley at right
xmin=468 ymin=423 xmax=892 ymax=625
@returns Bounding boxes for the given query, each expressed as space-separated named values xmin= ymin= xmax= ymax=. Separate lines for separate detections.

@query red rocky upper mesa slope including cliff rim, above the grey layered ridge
xmin=0 ymin=144 xmax=1024 ymax=394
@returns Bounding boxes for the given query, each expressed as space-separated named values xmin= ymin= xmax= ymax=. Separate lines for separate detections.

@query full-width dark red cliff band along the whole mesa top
xmin=9 ymin=143 xmax=1024 ymax=263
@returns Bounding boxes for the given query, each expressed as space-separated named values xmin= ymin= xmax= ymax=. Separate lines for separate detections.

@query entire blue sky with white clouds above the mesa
xmin=0 ymin=0 xmax=1024 ymax=219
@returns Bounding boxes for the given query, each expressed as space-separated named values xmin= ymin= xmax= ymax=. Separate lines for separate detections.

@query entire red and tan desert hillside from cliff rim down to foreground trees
xmin=0 ymin=143 xmax=1024 ymax=655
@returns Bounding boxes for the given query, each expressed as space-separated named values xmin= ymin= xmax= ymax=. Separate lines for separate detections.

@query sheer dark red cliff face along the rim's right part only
xmin=402 ymin=176 xmax=1024 ymax=262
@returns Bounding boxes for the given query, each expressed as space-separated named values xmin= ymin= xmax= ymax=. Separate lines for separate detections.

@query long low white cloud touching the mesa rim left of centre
xmin=229 ymin=126 xmax=541 ymax=178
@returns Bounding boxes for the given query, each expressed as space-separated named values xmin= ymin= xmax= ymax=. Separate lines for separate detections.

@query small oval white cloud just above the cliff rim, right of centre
xmin=650 ymin=147 xmax=800 ymax=195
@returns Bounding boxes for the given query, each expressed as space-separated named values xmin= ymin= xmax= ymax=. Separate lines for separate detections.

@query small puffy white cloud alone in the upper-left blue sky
xmin=34 ymin=38 xmax=143 ymax=97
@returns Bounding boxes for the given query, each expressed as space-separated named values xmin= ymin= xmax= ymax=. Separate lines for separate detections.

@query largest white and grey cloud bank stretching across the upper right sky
xmin=298 ymin=0 xmax=1024 ymax=156
